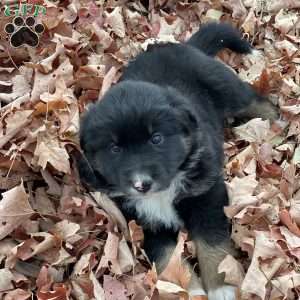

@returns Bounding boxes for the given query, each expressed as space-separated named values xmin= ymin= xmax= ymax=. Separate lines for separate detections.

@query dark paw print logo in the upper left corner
xmin=4 ymin=16 xmax=45 ymax=48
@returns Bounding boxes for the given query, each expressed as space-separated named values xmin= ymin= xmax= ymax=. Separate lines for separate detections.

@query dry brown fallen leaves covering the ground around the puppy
xmin=0 ymin=0 xmax=300 ymax=300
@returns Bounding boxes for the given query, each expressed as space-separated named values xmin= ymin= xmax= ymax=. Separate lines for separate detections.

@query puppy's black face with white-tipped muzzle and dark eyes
xmin=80 ymin=82 xmax=192 ymax=196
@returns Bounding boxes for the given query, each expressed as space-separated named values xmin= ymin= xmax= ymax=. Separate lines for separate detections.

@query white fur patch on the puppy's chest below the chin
xmin=127 ymin=174 xmax=182 ymax=230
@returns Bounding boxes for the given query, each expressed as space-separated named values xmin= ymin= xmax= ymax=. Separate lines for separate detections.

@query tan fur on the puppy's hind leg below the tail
xmin=237 ymin=100 xmax=279 ymax=121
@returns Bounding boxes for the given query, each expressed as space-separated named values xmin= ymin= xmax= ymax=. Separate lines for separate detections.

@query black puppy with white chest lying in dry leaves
xmin=79 ymin=23 xmax=276 ymax=300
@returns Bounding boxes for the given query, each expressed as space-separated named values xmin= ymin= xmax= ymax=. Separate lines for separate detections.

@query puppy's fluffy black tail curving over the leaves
xmin=187 ymin=22 xmax=251 ymax=56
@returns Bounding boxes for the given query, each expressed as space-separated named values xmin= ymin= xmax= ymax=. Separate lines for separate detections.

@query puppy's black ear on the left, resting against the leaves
xmin=76 ymin=153 xmax=108 ymax=191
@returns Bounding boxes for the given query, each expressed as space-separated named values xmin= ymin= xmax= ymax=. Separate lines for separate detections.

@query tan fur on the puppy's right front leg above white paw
xmin=194 ymin=239 xmax=233 ymax=291
